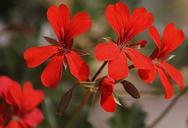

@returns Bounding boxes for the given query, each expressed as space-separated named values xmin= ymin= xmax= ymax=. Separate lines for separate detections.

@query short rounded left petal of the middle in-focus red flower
xmin=95 ymin=42 xmax=120 ymax=61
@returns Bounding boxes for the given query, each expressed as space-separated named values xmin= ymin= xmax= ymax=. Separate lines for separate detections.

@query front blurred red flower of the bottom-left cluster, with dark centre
xmin=4 ymin=82 xmax=44 ymax=128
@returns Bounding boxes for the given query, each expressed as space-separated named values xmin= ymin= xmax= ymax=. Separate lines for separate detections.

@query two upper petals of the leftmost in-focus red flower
xmin=47 ymin=4 xmax=91 ymax=49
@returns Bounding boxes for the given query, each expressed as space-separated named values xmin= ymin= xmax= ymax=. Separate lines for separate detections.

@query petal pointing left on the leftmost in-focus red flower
xmin=24 ymin=46 xmax=58 ymax=68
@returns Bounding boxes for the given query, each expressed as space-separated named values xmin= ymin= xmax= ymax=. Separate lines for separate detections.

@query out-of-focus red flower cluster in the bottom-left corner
xmin=0 ymin=76 xmax=44 ymax=128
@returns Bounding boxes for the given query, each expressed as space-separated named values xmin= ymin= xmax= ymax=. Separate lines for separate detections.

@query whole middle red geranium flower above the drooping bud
xmin=95 ymin=2 xmax=153 ymax=80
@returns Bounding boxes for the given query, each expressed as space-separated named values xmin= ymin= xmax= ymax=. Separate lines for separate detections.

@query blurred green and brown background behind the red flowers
xmin=0 ymin=0 xmax=188 ymax=128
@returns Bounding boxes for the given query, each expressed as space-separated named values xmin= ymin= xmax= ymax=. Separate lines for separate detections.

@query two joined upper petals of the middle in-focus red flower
xmin=105 ymin=2 xmax=153 ymax=44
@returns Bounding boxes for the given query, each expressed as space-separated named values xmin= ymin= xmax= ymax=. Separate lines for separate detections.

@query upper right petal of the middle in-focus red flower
xmin=127 ymin=8 xmax=154 ymax=40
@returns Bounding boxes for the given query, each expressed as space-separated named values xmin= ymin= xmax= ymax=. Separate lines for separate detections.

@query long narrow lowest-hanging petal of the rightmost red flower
xmin=157 ymin=68 xmax=174 ymax=99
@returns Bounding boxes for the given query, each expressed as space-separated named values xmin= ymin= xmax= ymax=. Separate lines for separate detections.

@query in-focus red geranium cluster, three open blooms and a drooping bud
xmin=24 ymin=2 xmax=185 ymax=112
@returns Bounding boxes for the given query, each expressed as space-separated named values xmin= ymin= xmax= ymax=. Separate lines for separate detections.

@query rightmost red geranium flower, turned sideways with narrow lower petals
xmin=138 ymin=23 xmax=185 ymax=98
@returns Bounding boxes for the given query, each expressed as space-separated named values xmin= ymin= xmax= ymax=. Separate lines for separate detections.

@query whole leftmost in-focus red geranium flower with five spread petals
xmin=24 ymin=4 xmax=91 ymax=88
